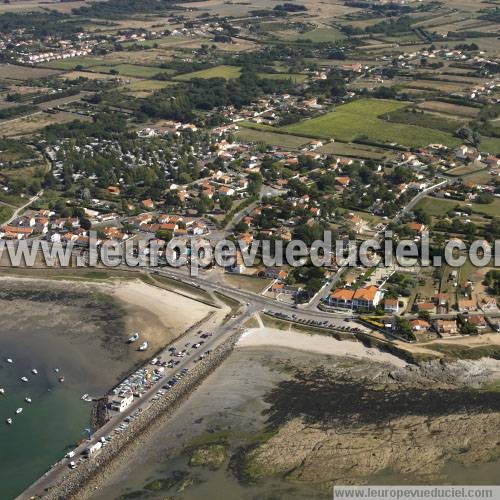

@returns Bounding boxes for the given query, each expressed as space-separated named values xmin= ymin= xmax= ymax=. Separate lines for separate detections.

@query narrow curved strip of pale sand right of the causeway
xmin=238 ymin=327 xmax=406 ymax=368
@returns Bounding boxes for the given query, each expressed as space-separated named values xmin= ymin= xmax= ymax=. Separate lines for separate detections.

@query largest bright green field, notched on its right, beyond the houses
xmin=284 ymin=99 xmax=460 ymax=147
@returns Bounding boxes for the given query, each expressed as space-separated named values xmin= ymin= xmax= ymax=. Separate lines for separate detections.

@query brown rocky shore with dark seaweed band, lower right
xmin=238 ymin=359 xmax=500 ymax=491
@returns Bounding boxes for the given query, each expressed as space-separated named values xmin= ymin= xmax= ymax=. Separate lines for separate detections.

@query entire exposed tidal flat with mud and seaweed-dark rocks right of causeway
xmin=85 ymin=347 xmax=500 ymax=500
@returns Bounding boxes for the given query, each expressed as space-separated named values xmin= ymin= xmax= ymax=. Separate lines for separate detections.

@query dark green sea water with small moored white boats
xmin=0 ymin=352 xmax=91 ymax=498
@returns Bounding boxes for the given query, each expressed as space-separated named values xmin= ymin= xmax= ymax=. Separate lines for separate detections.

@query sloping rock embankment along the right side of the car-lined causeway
xmin=41 ymin=332 xmax=240 ymax=500
